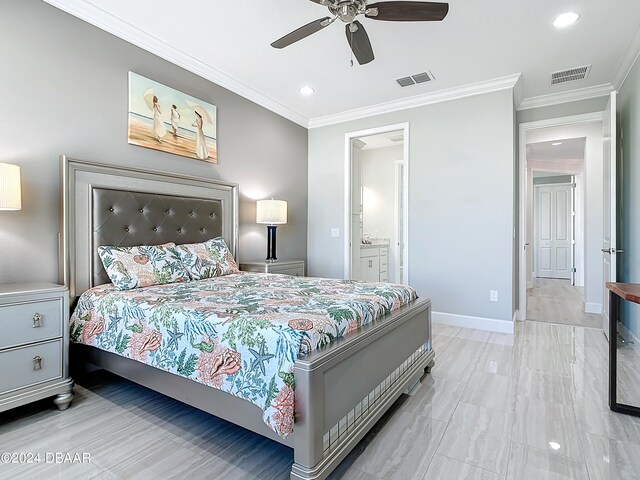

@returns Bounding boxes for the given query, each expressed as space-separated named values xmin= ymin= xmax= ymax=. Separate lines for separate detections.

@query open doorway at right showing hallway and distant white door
xmin=527 ymin=137 xmax=601 ymax=328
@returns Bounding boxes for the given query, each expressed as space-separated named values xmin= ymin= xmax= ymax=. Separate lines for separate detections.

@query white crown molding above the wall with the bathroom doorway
xmin=309 ymin=73 xmax=520 ymax=128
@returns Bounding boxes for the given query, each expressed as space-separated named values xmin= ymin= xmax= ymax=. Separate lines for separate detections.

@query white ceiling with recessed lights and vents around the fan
xmin=46 ymin=0 xmax=640 ymax=124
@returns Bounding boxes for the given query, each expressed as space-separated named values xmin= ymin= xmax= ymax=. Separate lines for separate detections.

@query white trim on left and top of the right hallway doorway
xmin=517 ymin=112 xmax=604 ymax=320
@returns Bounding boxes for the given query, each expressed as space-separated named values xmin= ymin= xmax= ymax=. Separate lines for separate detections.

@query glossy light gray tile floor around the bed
xmin=0 ymin=321 xmax=640 ymax=480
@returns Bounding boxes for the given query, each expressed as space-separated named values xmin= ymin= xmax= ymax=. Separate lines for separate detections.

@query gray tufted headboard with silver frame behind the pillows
xmin=60 ymin=156 xmax=238 ymax=300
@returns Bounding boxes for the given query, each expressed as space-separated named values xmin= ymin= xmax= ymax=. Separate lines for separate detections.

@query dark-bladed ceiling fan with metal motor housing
xmin=271 ymin=0 xmax=449 ymax=65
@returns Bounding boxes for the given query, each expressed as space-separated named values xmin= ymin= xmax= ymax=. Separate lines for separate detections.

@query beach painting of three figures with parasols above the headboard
xmin=129 ymin=72 xmax=218 ymax=163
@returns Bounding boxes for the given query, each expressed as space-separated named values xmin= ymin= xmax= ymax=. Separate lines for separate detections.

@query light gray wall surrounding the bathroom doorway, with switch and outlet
xmin=307 ymin=90 xmax=514 ymax=322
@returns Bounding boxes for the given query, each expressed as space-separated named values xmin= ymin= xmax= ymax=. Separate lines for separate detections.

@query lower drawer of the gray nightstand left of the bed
xmin=0 ymin=340 xmax=62 ymax=393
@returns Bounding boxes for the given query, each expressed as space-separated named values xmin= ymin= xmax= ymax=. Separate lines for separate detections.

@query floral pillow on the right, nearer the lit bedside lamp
xmin=176 ymin=237 xmax=240 ymax=280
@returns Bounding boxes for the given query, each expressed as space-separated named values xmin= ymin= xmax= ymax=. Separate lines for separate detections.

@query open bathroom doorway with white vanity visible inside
xmin=345 ymin=124 xmax=408 ymax=284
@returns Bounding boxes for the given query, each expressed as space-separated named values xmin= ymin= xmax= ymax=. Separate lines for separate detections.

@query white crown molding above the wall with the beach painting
xmin=44 ymin=0 xmax=309 ymax=128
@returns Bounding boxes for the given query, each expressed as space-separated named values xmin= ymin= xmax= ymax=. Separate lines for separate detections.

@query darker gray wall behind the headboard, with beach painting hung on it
xmin=0 ymin=0 xmax=307 ymax=283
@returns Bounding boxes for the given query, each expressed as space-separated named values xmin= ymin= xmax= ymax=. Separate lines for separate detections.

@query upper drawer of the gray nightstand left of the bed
xmin=0 ymin=298 xmax=63 ymax=349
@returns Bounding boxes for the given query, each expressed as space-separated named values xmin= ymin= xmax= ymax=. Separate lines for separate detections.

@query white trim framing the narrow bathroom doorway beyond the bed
xmin=343 ymin=122 xmax=410 ymax=285
